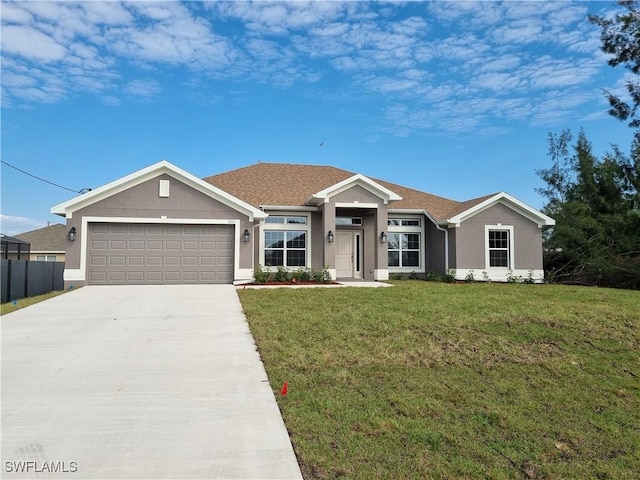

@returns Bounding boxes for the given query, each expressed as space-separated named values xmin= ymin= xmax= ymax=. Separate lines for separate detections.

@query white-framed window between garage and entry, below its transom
xmin=264 ymin=231 xmax=307 ymax=267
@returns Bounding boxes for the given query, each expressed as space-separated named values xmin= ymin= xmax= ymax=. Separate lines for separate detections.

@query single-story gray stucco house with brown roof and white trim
xmin=51 ymin=161 xmax=554 ymax=285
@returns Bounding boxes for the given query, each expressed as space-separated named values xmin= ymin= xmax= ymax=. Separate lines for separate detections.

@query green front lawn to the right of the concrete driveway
xmin=238 ymin=281 xmax=640 ymax=479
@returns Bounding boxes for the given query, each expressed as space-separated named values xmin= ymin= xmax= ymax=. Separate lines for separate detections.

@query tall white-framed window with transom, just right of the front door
xmin=387 ymin=216 xmax=425 ymax=272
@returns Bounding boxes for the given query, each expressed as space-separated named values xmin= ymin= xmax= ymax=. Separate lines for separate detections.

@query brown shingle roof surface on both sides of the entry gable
xmin=204 ymin=163 xmax=491 ymax=220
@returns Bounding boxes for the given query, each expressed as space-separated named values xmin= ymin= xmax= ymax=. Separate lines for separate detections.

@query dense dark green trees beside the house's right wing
xmin=537 ymin=130 xmax=640 ymax=289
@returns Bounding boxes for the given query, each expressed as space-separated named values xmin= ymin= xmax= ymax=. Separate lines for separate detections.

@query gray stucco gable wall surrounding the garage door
xmin=66 ymin=174 xmax=255 ymax=278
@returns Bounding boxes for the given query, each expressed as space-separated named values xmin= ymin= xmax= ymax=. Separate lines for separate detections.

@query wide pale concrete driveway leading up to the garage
xmin=1 ymin=285 xmax=302 ymax=479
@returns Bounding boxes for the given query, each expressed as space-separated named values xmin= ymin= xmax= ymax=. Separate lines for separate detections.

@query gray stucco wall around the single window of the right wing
xmin=452 ymin=204 xmax=542 ymax=270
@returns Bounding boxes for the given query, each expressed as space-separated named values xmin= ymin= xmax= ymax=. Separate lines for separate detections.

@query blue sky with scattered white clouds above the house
xmin=1 ymin=1 xmax=631 ymax=235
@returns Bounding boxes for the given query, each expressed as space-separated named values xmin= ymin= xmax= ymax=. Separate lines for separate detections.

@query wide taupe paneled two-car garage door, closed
xmin=87 ymin=223 xmax=234 ymax=285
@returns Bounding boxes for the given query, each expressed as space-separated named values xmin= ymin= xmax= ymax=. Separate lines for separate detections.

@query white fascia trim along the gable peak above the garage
xmin=51 ymin=160 xmax=267 ymax=220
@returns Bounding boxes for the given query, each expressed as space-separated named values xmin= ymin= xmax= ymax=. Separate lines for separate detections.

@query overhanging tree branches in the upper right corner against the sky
xmin=589 ymin=0 xmax=640 ymax=128
